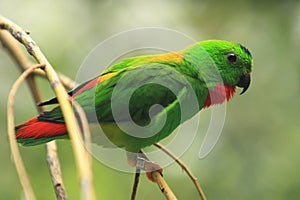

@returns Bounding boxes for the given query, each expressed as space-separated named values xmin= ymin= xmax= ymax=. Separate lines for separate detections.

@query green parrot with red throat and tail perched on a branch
xmin=15 ymin=40 xmax=253 ymax=178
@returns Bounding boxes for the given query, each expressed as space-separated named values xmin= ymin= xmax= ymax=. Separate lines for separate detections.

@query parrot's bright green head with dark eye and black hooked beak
xmin=186 ymin=40 xmax=252 ymax=94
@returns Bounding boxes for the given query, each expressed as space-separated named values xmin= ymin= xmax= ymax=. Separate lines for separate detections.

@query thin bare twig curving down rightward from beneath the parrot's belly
xmin=154 ymin=143 xmax=206 ymax=200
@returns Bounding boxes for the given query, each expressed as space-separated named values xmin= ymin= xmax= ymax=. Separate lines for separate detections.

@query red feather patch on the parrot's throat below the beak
xmin=203 ymin=84 xmax=235 ymax=108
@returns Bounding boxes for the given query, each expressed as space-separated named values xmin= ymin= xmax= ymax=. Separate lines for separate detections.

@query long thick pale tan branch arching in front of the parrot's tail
xmin=0 ymin=16 xmax=95 ymax=199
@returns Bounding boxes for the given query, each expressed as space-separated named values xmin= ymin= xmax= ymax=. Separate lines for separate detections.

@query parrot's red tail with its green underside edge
xmin=15 ymin=117 xmax=68 ymax=146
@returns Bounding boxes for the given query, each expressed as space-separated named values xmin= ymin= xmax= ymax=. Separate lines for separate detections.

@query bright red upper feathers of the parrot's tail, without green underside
xmin=16 ymin=118 xmax=67 ymax=138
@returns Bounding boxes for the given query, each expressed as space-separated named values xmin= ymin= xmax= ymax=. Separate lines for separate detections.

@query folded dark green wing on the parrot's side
xmin=40 ymin=63 xmax=205 ymax=124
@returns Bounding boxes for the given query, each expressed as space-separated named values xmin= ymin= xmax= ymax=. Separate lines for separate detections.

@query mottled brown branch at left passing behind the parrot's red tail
xmin=0 ymin=27 xmax=67 ymax=200
